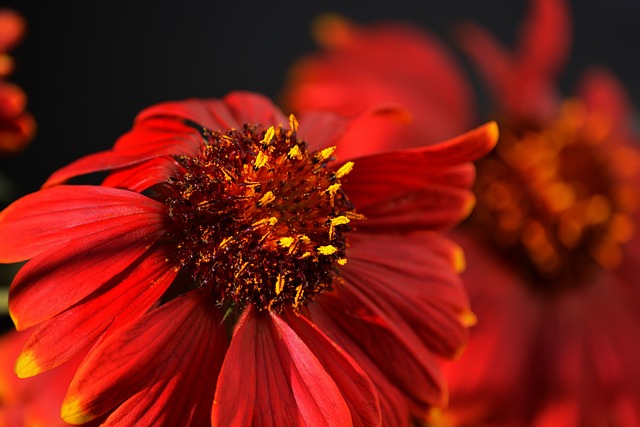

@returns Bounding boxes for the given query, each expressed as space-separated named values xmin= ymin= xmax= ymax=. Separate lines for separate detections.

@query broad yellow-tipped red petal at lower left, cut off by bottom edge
xmin=62 ymin=291 xmax=226 ymax=427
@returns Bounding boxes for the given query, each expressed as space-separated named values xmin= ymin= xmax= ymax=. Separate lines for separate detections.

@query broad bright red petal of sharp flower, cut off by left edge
xmin=0 ymin=186 xmax=166 ymax=263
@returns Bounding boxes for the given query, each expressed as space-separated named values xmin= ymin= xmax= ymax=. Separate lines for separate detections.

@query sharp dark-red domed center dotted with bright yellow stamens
xmin=167 ymin=116 xmax=362 ymax=311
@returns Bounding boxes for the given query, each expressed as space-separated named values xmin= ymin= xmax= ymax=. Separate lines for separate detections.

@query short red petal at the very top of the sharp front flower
xmin=223 ymin=92 xmax=289 ymax=125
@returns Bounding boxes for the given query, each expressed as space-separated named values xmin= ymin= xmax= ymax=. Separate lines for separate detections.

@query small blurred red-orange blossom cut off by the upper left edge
xmin=0 ymin=9 xmax=36 ymax=154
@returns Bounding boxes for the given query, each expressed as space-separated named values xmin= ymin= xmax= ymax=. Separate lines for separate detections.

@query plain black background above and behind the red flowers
xmin=0 ymin=0 xmax=640 ymax=332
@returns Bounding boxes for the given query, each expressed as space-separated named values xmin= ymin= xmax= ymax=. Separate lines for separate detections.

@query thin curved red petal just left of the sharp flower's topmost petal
xmin=136 ymin=99 xmax=243 ymax=131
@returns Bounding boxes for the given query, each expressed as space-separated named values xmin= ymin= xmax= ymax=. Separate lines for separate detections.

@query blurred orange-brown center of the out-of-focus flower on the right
xmin=470 ymin=102 xmax=640 ymax=291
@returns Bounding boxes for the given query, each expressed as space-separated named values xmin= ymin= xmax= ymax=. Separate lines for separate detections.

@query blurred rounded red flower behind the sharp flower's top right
xmin=283 ymin=16 xmax=474 ymax=160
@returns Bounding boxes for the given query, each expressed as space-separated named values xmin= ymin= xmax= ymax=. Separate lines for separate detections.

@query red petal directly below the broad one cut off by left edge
xmin=9 ymin=206 xmax=165 ymax=330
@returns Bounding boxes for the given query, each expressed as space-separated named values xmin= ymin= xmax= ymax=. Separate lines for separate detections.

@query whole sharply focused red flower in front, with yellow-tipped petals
xmin=0 ymin=93 xmax=497 ymax=426
